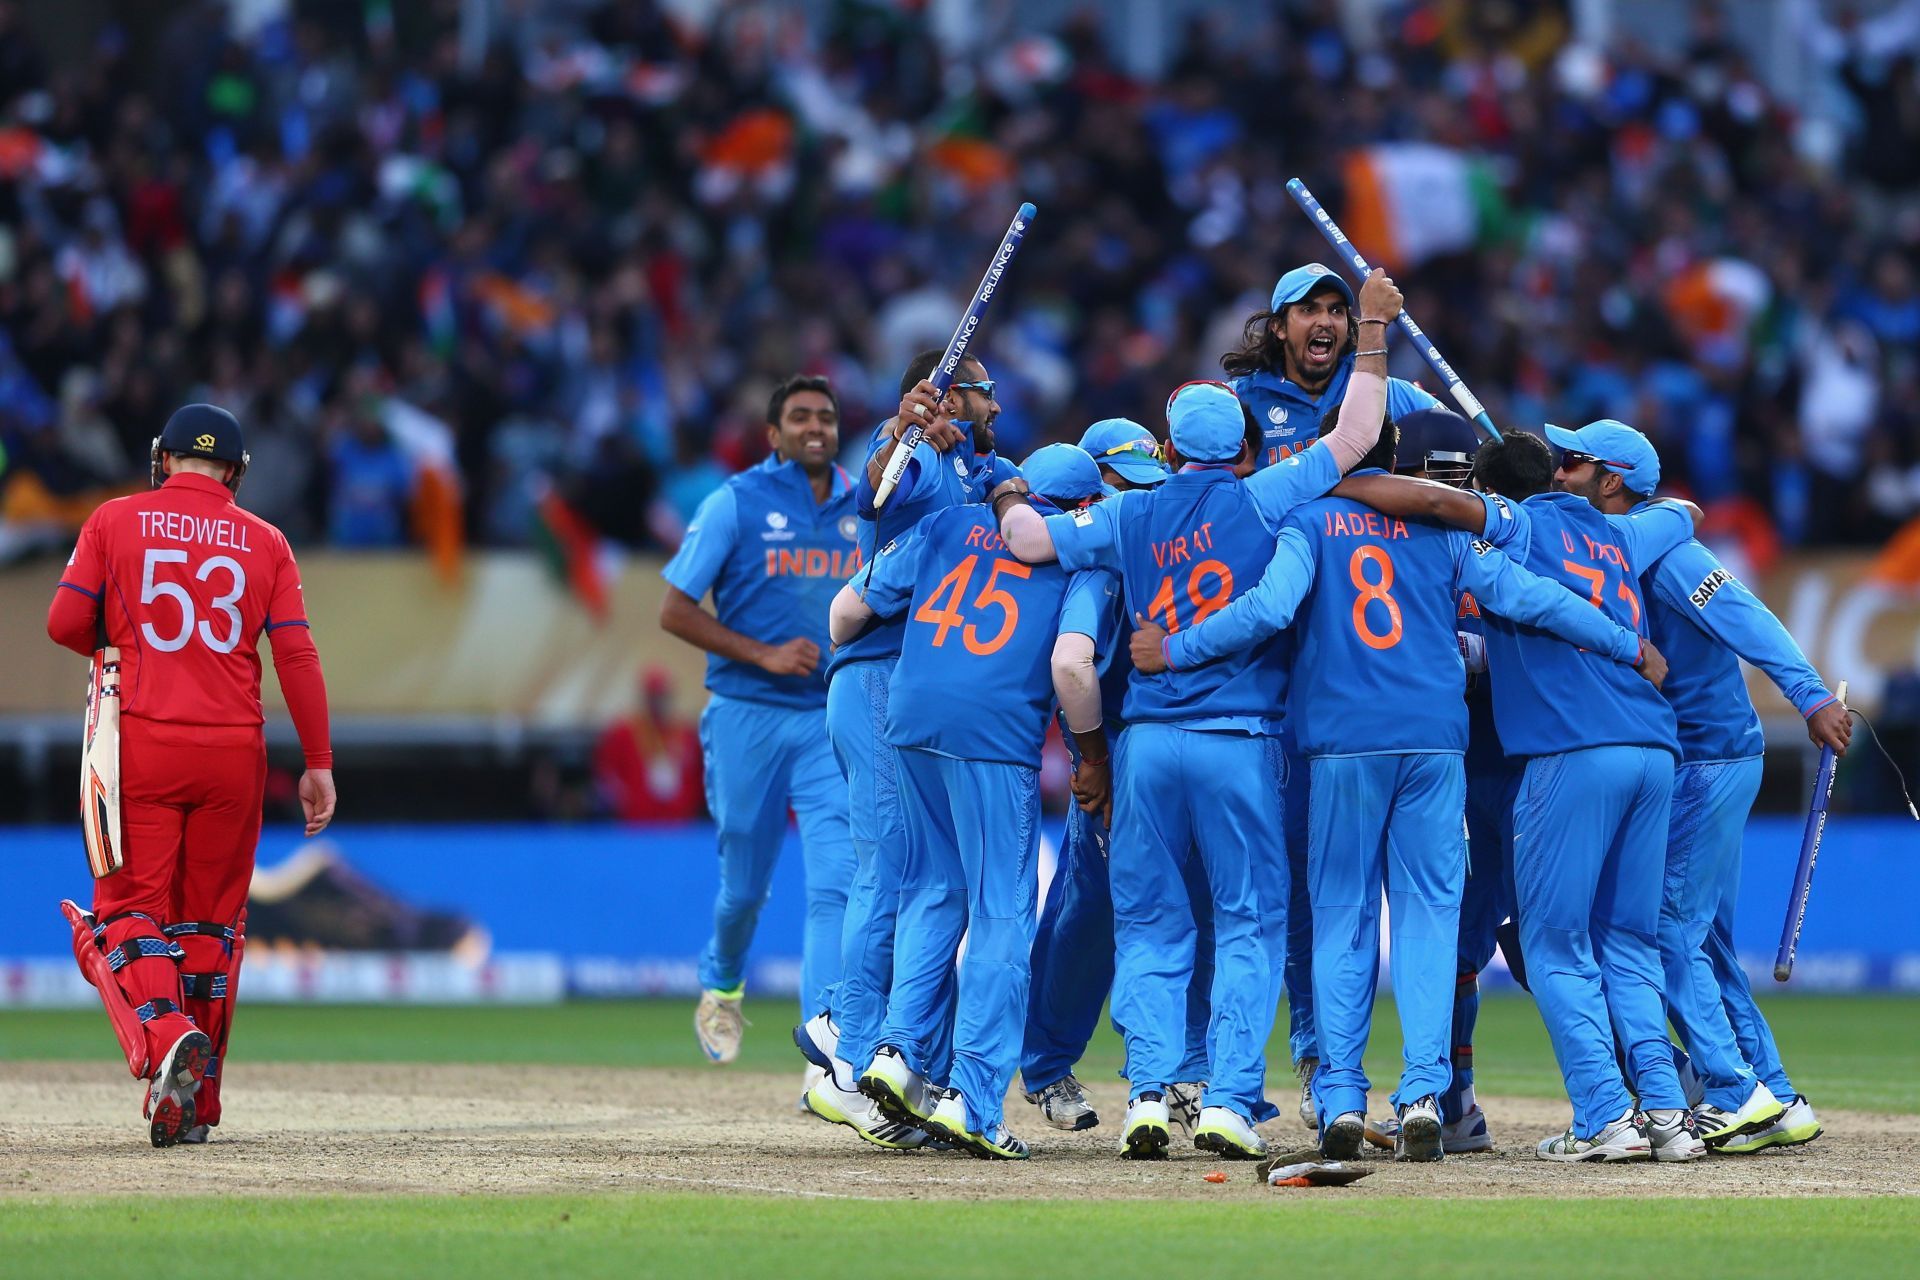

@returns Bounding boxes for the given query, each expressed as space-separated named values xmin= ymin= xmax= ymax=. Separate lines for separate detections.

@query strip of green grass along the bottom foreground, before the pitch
xmin=0 ymin=1194 xmax=1920 ymax=1280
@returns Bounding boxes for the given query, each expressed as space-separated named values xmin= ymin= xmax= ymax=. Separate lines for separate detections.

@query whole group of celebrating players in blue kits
xmin=662 ymin=265 xmax=1851 ymax=1161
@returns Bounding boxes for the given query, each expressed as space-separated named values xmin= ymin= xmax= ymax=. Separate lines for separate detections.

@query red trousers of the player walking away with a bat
xmin=94 ymin=716 xmax=267 ymax=1123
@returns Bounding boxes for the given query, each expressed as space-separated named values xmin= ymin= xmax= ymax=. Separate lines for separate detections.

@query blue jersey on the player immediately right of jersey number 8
xmin=1476 ymin=493 xmax=1693 ymax=756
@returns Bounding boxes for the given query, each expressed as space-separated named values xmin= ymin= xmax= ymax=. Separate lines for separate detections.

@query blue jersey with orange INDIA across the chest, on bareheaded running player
xmin=660 ymin=457 xmax=860 ymax=706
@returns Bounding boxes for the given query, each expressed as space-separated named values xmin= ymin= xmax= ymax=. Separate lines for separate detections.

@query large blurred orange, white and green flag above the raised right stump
xmin=1340 ymin=142 xmax=1505 ymax=271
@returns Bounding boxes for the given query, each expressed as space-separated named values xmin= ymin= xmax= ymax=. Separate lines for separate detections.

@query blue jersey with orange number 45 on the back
xmin=866 ymin=503 xmax=1068 ymax=770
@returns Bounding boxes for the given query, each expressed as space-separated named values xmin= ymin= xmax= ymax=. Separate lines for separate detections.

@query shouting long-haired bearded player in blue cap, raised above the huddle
xmin=1219 ymin=263 xmax=1440 ymax=1128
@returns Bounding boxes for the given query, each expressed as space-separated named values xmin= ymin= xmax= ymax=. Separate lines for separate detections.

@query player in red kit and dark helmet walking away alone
xmin=46 ymin=405 xmax=334 ymax=1146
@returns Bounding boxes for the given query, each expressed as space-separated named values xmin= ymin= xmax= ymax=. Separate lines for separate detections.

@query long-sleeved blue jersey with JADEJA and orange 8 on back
xmin=1167 ymin=472 xmax=1640 ymax=756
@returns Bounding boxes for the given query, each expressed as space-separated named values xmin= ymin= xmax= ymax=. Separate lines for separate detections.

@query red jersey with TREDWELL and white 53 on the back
xmin=50 ymin=472 xmax=330 ymax=764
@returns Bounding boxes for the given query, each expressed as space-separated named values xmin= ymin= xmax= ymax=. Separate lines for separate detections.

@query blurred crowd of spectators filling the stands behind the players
xmin=0 ymin=0 xmax=1920 ymax=558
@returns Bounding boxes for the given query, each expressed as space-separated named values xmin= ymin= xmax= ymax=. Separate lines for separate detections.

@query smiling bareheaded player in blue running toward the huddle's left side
xmin=660 ymin=376 xmax=860 ymax=1063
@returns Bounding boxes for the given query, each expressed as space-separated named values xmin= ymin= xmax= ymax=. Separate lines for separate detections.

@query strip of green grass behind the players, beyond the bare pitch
xmin=11 ymin=996 xmax=1920 ymax=1111
